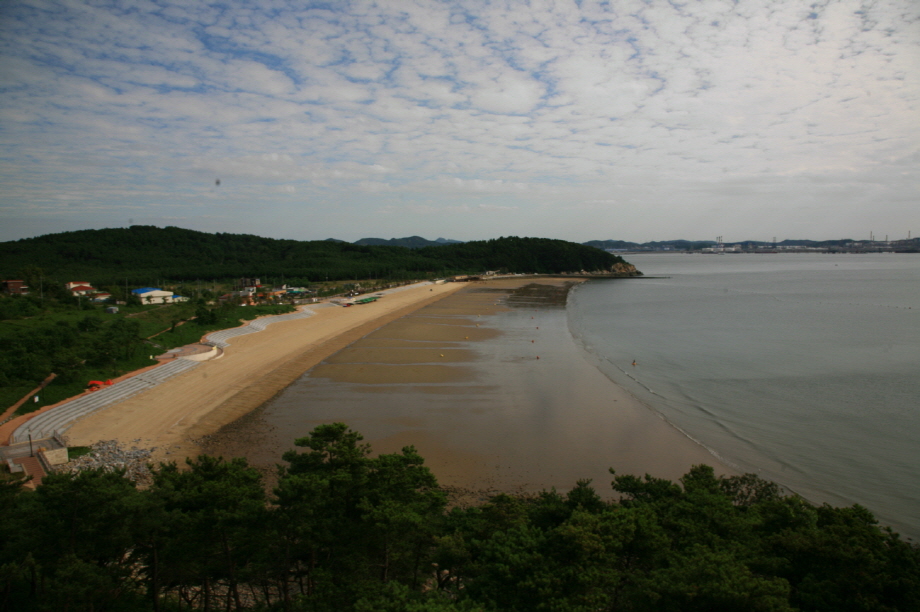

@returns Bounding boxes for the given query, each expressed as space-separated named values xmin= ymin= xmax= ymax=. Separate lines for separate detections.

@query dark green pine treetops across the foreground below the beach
xmin=0 ymin=424 xmax=920 ymax=612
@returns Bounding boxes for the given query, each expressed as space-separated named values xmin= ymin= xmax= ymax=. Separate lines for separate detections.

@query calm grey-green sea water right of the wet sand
xmin=567 ymin=254 xmax=920 ymax=539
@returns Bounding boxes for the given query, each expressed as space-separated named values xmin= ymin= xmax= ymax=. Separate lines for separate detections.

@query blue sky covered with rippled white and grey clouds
xmin=0 ymin=0 xmax=920 ymax=242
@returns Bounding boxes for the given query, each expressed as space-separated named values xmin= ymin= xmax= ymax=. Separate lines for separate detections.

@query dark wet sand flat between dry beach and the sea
xmin=205 ymin=279 xmax=732 ymax=492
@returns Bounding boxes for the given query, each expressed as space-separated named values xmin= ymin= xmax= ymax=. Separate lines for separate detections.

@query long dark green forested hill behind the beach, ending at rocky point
xmin=0 ymin=225 xmax=623 ymax=284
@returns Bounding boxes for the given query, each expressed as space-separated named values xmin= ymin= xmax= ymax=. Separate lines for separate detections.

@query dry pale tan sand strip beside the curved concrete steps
xmin=66 ymin=284 xmax=461 ymax=461
